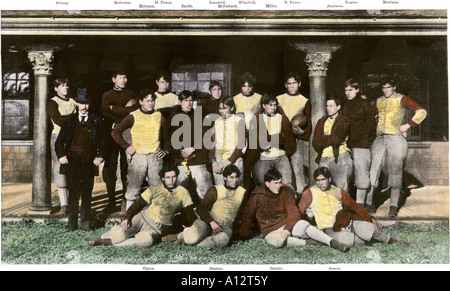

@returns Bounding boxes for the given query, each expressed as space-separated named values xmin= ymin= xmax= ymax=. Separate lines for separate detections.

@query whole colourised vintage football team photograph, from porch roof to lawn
xmin=1 ymin=9 xmax=449 ymax=271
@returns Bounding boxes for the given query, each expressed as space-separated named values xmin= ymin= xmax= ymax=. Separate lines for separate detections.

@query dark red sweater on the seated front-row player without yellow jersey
xmin=239 ymin=184 xmax=301 ymax=238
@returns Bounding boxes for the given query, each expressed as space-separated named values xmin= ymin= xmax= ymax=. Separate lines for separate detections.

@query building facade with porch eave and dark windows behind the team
xmin=1 ymin=10 xmax=449 ymax=209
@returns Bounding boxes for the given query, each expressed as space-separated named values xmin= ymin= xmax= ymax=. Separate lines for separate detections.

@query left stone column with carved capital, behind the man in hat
xmin=25 ymin=45 xmax=57 ymax=214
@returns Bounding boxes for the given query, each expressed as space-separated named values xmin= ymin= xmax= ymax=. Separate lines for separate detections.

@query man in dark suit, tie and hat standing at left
xmin=55 ymin=96 xmax=103 ymax=230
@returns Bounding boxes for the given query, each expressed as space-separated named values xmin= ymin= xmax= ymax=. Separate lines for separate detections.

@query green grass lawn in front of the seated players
xmin=1 ymin=219 xmax=449 ymax=265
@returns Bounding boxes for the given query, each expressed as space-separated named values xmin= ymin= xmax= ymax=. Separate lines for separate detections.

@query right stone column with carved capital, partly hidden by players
xmin=291 ymin=42 xmax=340 ymax=186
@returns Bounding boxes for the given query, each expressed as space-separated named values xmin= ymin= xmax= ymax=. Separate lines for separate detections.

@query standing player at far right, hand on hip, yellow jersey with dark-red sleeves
xmin=366 ymin=79 xmax=427 ymax=217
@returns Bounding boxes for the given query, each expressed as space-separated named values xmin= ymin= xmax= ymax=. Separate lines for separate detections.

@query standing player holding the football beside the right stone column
xmin=277 ymin=72 xmax=311 ymax=194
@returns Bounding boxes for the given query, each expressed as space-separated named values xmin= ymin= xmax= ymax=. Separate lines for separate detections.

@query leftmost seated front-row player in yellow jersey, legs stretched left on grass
xmin=90 ymin=165 xmax=196 ymax=247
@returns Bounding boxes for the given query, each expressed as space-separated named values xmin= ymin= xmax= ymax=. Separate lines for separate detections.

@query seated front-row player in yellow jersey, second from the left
xmin=176 ymin=164 xmax=246 ymax=248
